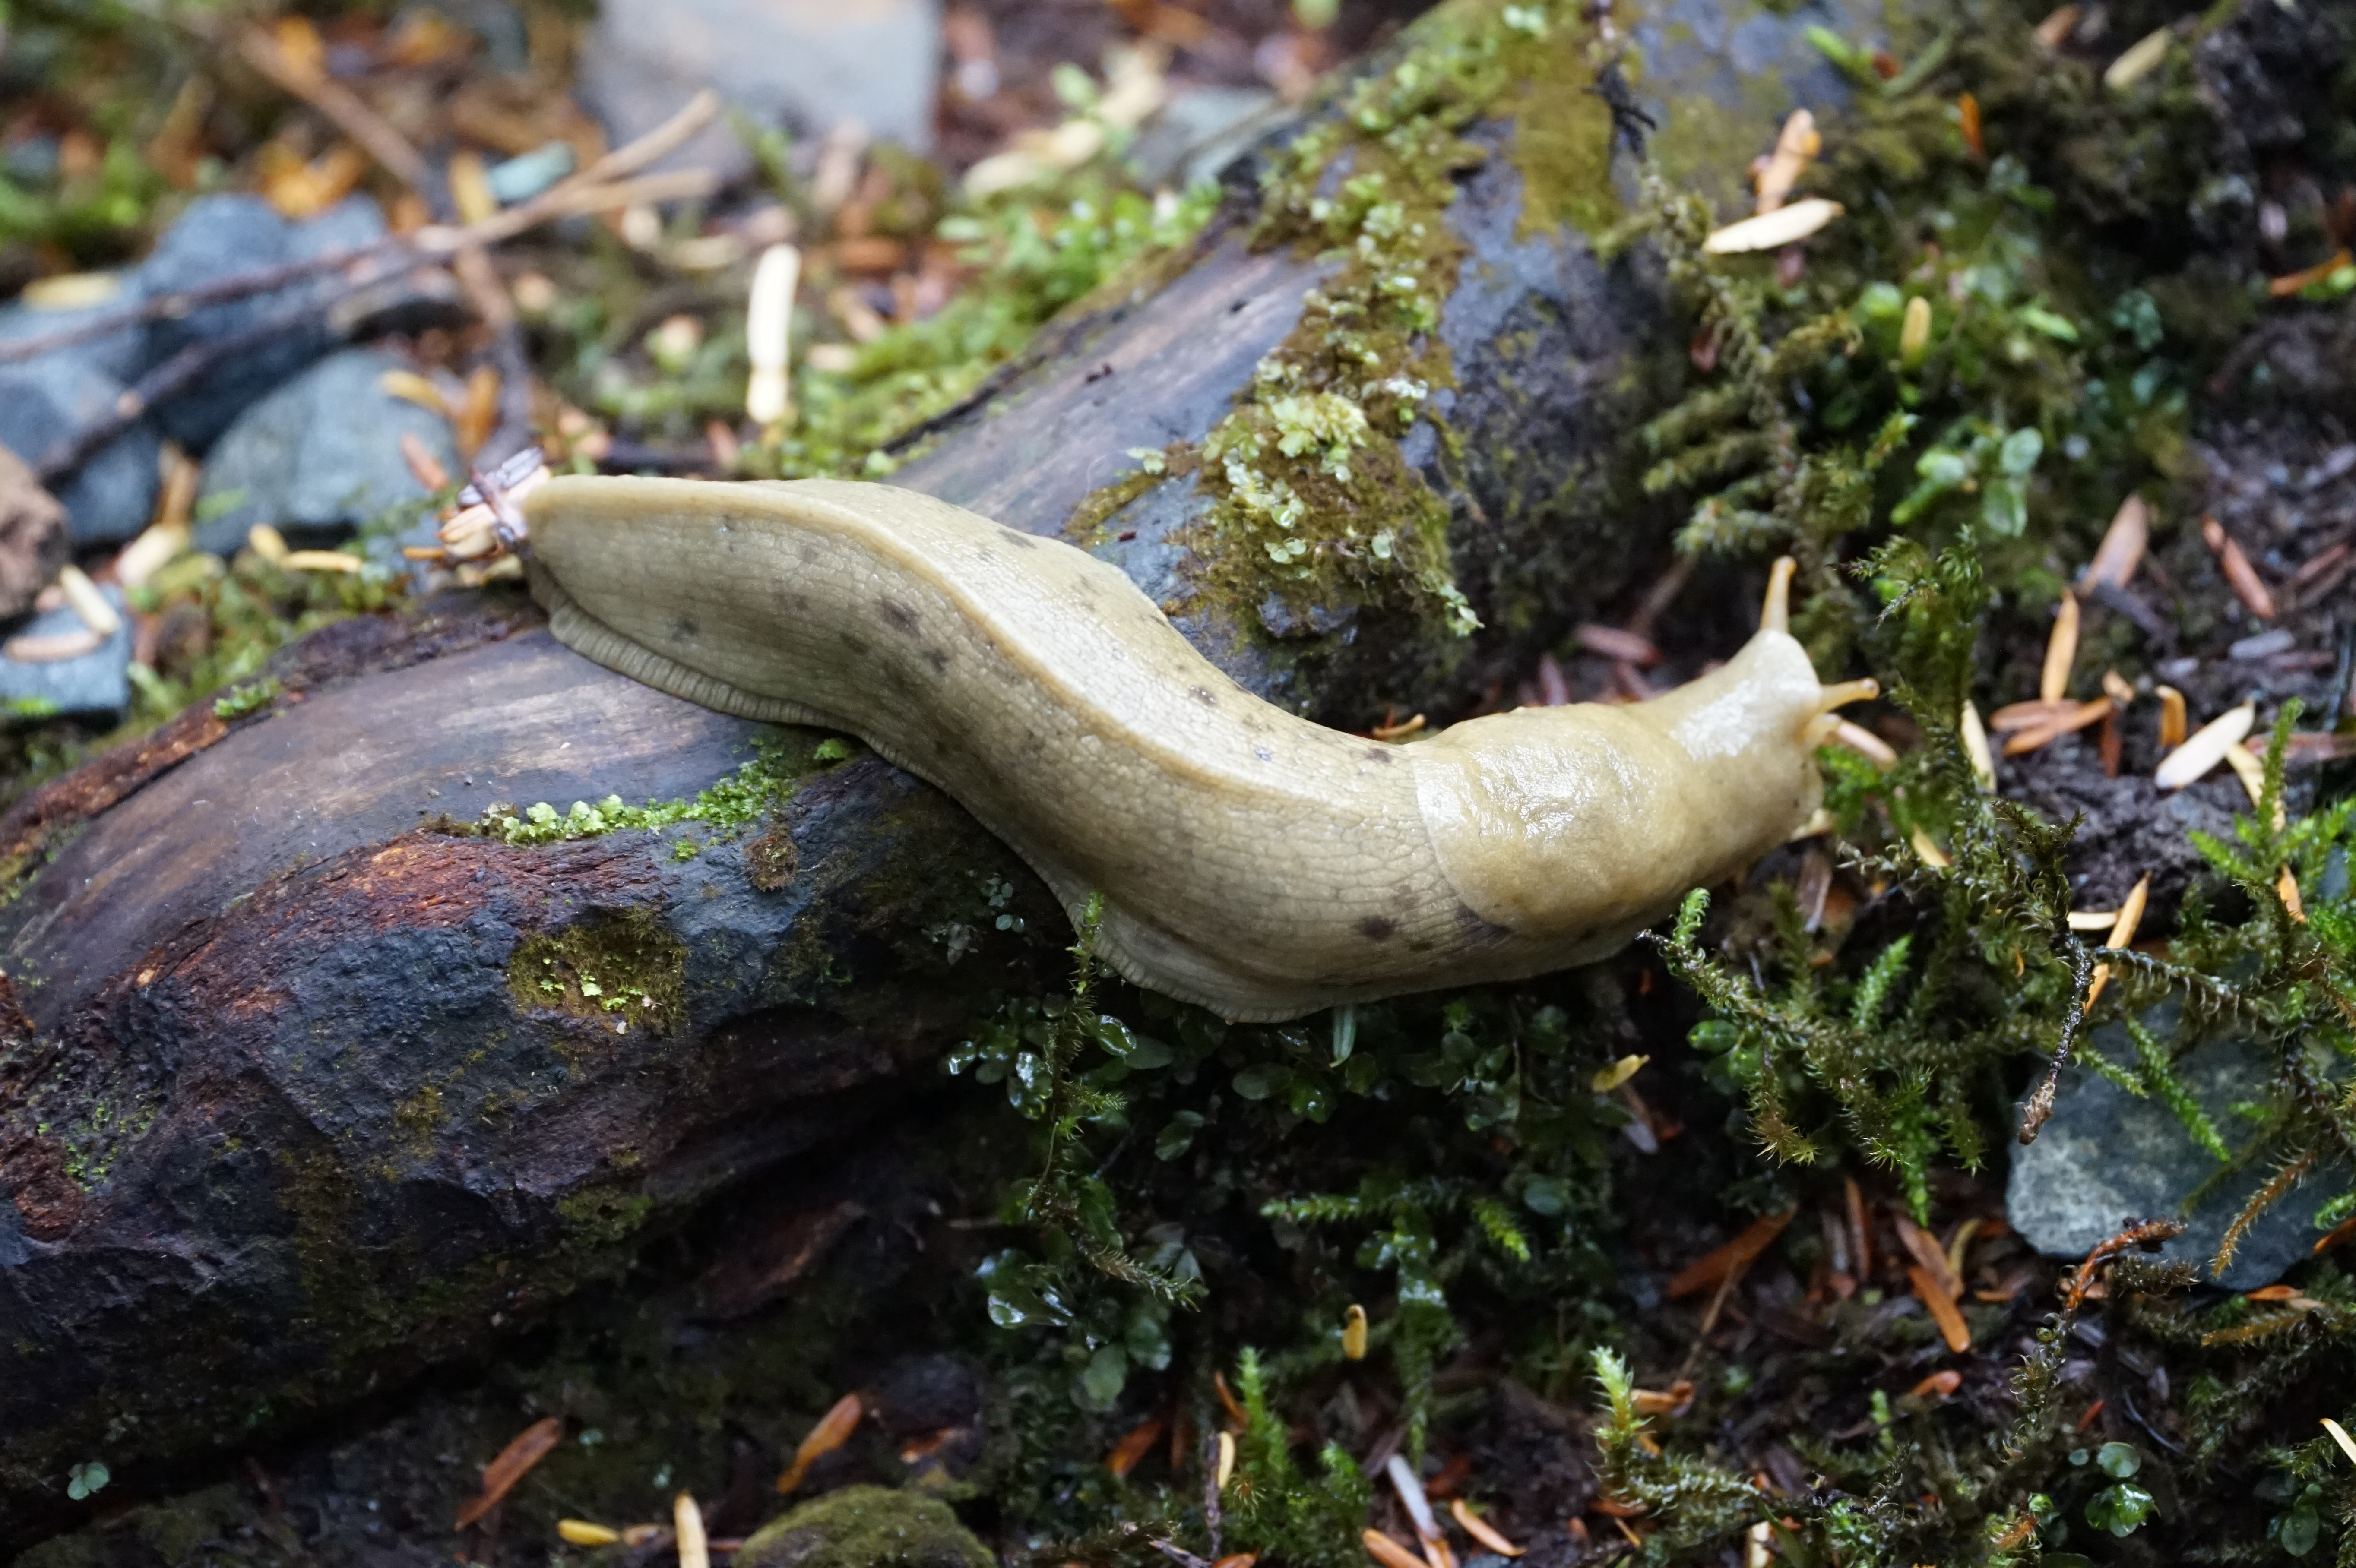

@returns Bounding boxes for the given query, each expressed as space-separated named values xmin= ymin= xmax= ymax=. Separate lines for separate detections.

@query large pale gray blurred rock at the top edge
xmin=580 ymin=0 xmax=942 ymax=177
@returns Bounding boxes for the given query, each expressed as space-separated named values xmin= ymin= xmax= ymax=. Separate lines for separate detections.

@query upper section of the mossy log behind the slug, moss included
xmin=893 ymin=0 xmax=1894 ymax=727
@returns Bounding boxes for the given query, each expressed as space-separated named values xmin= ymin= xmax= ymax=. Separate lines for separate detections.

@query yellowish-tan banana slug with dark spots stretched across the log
xmin=521 ymin=478 xmax=1871 ymax=1019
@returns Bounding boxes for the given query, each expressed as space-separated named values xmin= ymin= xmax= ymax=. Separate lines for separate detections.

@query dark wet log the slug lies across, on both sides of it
xmin=0 ymin=0 xmax=1871 ymax=1549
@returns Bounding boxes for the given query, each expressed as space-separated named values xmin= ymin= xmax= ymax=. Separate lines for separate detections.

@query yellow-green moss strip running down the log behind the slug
xmin=1192 ymin=5 xmax=1609 ymax=635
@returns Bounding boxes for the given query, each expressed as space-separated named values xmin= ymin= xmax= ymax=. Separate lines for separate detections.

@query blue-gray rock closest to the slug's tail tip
xmin=196 ymin=348 xmax=459 ymax=556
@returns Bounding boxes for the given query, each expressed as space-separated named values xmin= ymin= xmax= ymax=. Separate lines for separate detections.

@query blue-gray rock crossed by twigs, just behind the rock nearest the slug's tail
xmin=139 ymin=196 xmax=384 ymax=452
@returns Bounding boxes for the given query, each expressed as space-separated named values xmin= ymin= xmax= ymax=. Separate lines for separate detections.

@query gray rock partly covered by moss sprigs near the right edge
xmin=2005 ymin=1010 xmax=2346 ymax=1290
